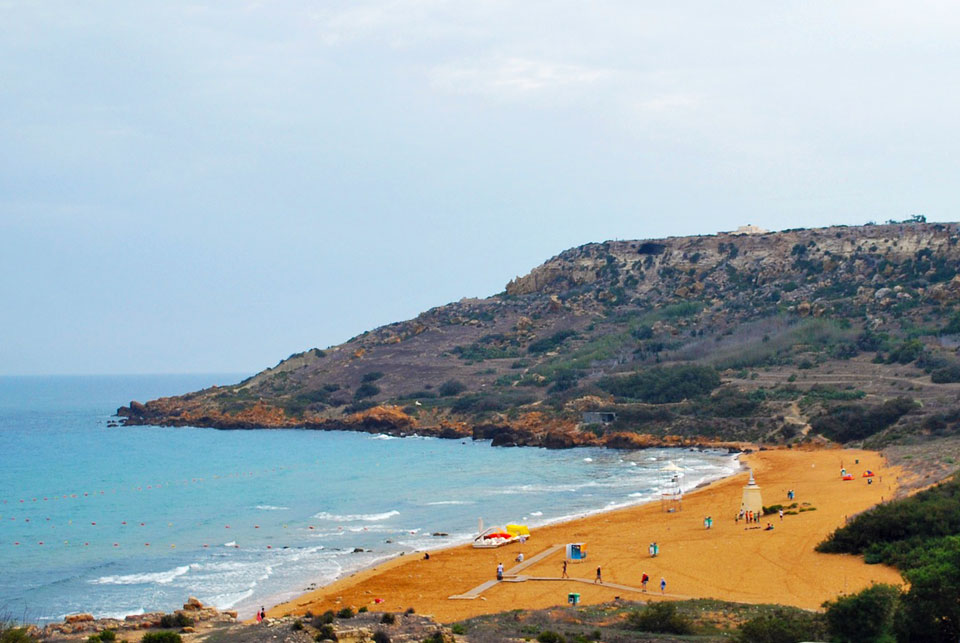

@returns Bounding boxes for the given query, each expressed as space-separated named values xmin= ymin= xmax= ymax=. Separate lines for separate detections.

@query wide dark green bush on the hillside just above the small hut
xmin=597 ymin=366 xmax=720 ymax=404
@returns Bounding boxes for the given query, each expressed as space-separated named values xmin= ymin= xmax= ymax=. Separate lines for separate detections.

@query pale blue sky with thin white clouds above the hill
xmin=0 ymin=0 xmax=960 ymax=374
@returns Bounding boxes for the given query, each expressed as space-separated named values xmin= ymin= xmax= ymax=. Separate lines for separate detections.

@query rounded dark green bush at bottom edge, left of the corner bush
xmin=823 ymin=585 xmax=900 ymax=643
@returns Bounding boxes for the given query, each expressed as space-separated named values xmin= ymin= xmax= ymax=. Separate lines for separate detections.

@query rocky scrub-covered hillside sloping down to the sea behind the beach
xmin=118 ymin=217 xmax=960 ymax=447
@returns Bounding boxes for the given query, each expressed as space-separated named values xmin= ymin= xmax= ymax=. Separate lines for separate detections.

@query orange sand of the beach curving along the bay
xmin=269 ymin=450 xmax=902 ymax=623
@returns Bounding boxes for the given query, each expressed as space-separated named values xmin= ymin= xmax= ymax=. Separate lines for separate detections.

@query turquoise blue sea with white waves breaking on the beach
xmin=0 ymin=374 xmax=739 ymax=624
